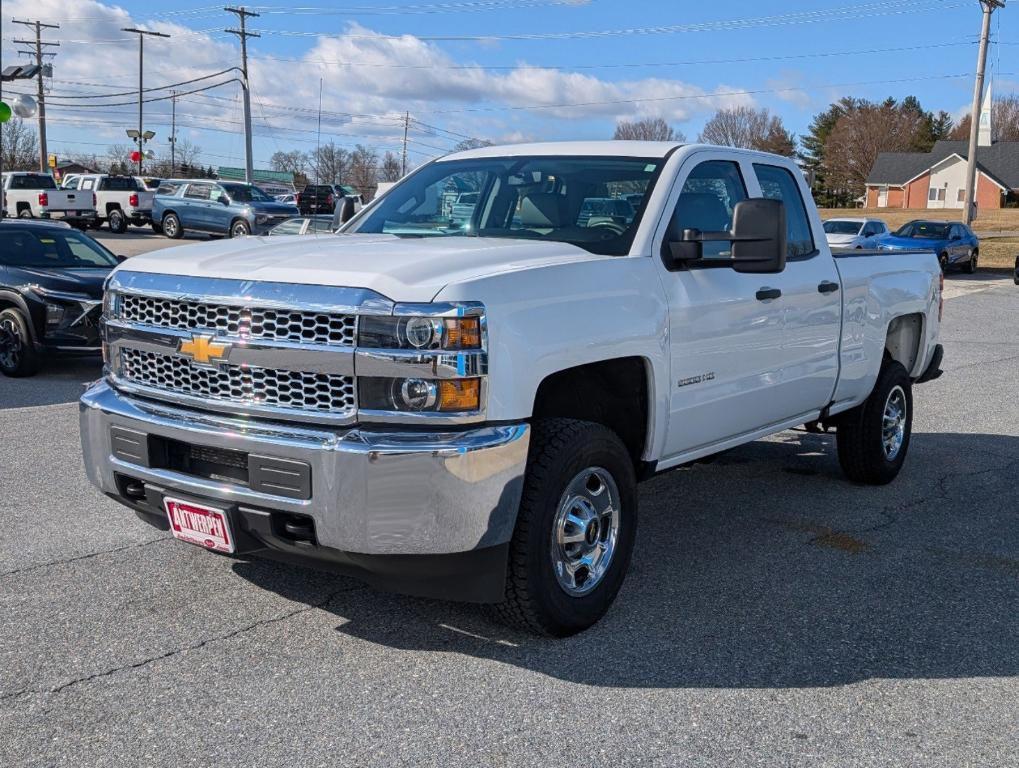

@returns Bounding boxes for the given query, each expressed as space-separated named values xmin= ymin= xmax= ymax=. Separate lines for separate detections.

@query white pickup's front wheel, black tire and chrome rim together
xmin=491 ymin=419 xmax=637 ymax=638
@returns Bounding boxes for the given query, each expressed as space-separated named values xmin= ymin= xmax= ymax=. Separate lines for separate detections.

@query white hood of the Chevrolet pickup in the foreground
xmin=118 ymin=234 xmax=613 ymax=301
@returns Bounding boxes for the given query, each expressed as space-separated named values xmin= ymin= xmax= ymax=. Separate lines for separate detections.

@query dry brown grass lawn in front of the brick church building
xmin=820 ymin=208 xmax=1019 ymax=269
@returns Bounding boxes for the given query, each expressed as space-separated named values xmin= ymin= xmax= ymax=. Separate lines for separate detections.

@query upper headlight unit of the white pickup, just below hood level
xmin=358 ymin=315 xmax=481 ymax=349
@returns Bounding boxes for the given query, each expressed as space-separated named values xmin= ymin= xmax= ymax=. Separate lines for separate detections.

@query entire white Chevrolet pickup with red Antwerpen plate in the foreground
xmin=82 ymin=142 xmax=942 ymax=636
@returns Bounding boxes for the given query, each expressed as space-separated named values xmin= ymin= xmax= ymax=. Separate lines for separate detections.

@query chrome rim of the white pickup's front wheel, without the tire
xmin=551 ymin=467 xmax=620 ymax=597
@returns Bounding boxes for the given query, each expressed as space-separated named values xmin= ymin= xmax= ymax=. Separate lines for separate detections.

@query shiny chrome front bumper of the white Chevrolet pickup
xmin=81 ymin=382 xmax=530 ymax=555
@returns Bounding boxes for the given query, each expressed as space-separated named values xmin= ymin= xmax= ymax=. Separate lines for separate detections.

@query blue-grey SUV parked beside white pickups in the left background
xmin=152 ymin=179 xmax=298 ymax=239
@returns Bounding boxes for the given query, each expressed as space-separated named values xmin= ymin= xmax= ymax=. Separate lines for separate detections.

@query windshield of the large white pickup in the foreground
xmin=346 ymin=157 xmax=664 ymax=256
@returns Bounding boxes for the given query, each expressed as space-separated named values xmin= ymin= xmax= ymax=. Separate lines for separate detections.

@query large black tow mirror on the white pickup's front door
xmin=663 ymin=198 xmax=786 ymax=274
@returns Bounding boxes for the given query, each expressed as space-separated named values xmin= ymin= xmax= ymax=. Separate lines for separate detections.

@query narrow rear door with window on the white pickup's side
xmin=753 ymin=162 xmax=842 ymax=416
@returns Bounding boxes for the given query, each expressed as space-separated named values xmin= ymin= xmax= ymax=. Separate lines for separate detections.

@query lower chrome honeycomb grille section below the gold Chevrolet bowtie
xmin=119 ymin=348 xmax=356 ymax=415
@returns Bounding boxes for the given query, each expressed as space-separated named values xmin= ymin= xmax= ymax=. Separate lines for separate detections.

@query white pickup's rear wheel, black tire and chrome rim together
xmin=836 ymin=361 xmax=913 ymax=485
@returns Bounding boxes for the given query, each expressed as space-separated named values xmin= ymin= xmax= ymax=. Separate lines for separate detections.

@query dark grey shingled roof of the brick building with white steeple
xmin=867 ymin=142 xmax=1019 ymax=189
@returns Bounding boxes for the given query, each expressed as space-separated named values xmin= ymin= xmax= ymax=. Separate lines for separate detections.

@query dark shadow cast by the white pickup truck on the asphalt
xmin=234 ymin=432 xmax=1019 ymax=689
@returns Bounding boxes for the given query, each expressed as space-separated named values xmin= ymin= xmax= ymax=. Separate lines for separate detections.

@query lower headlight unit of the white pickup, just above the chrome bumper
xmin=358 ymin=378 xmax=481 ymax=414
